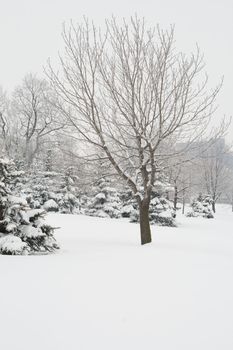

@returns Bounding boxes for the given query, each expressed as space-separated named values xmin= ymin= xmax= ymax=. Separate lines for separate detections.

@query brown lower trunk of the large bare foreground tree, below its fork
xmin=139 ymin=199 xmax=151 ymax=244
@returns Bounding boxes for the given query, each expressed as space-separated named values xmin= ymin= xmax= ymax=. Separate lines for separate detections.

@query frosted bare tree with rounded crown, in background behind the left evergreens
xmin=12 ymin=74 xmax=62 ymax=166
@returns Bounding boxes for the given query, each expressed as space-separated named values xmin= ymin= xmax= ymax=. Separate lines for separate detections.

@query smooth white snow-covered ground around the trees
xmin=0 ymin=206 xmax=233 ymax=350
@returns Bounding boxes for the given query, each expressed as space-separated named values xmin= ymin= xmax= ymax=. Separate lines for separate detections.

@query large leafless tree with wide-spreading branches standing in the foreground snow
xmin=47 ymin=17 xmax=224 ymax=244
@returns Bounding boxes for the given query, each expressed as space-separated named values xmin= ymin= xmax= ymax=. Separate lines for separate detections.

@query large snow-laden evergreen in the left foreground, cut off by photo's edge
xmin=0 ymin=159 xmax=59 ymax=255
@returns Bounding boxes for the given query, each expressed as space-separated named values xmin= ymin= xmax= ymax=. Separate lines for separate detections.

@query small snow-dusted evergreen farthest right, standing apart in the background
xmin=186 ymin=194 xmax=214 ymax=219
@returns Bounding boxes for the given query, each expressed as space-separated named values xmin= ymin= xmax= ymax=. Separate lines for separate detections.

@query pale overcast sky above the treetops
xmin=0 ymin=0 xmax=233 ymax=138
